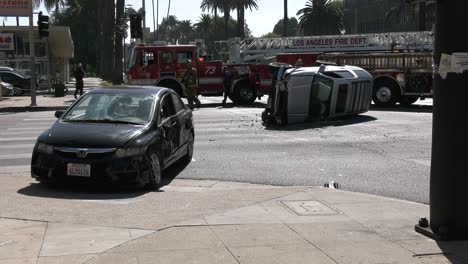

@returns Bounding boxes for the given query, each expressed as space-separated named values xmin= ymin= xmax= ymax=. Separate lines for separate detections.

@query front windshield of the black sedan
xmin=62 ymin=94 xmax=154 ymax=125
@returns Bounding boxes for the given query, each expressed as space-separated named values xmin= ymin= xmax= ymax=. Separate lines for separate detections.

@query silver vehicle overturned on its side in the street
xmin=262 ymin=64 xmax=372 ymax=125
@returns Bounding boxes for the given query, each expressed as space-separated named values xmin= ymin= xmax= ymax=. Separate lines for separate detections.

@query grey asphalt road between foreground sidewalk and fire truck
xmin=0 ymin=98 xmax=432 ymax=203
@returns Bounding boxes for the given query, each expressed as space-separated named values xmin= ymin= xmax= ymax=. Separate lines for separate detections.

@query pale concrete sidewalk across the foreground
xmin=0 ymin=175 xmax=468 ymax=264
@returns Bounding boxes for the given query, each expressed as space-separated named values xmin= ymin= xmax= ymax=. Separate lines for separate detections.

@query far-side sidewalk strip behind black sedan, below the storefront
xmin=0 ymin=78 xmax=101 ymax=112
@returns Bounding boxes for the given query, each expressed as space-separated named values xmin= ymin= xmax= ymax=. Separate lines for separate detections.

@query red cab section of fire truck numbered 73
xmin=126 ymin=44 xmax=317 ymax=104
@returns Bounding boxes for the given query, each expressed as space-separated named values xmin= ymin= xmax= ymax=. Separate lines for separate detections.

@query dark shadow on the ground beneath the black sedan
xmin=18 ymin=158 xmax=189 ymax=201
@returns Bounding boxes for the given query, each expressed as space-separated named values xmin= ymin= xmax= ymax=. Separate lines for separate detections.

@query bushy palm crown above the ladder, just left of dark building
xmin=297 ymin=0 xmax=344 ymax=36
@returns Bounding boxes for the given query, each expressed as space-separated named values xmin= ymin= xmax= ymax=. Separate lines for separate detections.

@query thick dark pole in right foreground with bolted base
xmin=416 ymin=0 xmax=468 ymax=240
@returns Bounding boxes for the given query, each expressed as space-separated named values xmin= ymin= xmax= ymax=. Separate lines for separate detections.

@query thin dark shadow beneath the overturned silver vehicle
xmin=265 ymin=115 xmax=377 ymax=131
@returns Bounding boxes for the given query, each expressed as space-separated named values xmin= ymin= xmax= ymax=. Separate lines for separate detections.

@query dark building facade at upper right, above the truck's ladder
xmin=344 ymin=0 xmax=435 ymax=34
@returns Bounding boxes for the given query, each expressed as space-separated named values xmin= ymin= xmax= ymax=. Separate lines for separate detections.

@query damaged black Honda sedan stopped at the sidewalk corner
xmin=31 ymin=86 xmax=195 ymax=189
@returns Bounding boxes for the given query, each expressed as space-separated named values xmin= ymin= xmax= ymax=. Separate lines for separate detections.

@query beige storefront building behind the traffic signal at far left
xmin=0 ymin=26 xmax=74 ymax=86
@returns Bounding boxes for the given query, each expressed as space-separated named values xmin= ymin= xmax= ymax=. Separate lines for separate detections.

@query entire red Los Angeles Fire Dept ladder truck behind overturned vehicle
xmin=126 ymin=32 xmax=433 ymax=105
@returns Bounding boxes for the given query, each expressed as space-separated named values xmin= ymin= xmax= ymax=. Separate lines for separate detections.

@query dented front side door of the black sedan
xmin=159 ymin=94 xmax=181 ymax=163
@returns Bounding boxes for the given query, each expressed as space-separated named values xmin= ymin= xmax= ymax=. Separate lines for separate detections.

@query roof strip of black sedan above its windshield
xmin=88 ymin=85 xmax=172 ymax=96
